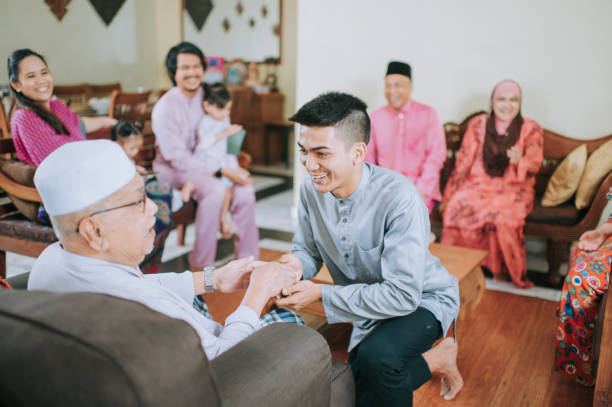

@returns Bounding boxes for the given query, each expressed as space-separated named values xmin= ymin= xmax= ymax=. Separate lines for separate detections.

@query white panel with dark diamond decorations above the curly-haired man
xmin=183 ymin=0 xmax=280 ymax=62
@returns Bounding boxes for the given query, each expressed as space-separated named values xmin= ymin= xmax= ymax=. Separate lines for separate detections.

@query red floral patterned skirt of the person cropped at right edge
xmin=555 ymin=225 xmax=612 ymax=386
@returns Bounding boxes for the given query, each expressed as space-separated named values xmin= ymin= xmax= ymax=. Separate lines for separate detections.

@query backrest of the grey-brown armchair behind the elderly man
xmin=0 ymin=290 xmax=220 ymax=406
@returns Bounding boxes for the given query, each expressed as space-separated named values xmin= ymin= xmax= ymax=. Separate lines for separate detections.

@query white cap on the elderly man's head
xmin=34 ymin=140 xmax=136 ymax=216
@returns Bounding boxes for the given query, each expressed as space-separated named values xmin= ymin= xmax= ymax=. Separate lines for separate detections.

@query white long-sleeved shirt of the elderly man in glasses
xmin=28 ymin=243 xmax=261 ymax=359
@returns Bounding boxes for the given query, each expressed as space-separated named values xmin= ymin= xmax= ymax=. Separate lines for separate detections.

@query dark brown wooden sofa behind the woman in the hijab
xmin=431 ymin=120 xmax=612 ymax=286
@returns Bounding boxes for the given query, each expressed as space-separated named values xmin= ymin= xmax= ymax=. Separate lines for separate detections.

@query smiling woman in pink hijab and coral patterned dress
xmin=440 ymin=81 xmax=542 ymax=288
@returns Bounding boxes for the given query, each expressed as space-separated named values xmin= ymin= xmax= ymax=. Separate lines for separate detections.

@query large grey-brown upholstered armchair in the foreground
xmin=0 ymin=275 xmax=355 ymax=407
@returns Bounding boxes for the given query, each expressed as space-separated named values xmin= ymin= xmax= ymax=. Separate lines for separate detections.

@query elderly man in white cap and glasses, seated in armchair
xmin=28 ymin=140 xmax=301 ymax=359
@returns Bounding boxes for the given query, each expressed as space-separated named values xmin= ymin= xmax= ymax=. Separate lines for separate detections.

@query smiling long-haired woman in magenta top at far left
xmin=8 ymin=49 xmax=116 ymax=167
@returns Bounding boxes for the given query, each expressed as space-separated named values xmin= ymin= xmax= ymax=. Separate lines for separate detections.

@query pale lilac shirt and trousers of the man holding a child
xmin=152 ymin=87 xmax=259 ymax=267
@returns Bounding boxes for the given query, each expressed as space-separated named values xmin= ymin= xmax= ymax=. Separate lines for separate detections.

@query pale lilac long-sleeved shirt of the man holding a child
xmin=152 ymin=87 xmax=219 ymax=175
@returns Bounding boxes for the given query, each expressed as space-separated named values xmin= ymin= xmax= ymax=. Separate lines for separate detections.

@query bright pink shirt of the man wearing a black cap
xmin=366 ymin=100 xmax=446 ymax=211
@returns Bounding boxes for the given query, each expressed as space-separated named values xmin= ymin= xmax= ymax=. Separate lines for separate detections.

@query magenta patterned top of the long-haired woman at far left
xmin=11 ymin=99 xmax=85 ymax=167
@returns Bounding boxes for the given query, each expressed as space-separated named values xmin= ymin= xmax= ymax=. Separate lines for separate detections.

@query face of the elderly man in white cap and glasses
xmin=95 ymin=174 xmax=157 ymax=266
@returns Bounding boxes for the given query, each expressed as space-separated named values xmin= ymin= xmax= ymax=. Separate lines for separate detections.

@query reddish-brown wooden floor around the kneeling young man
xmin=207 ymin=250 xmax=593 ymax=407
